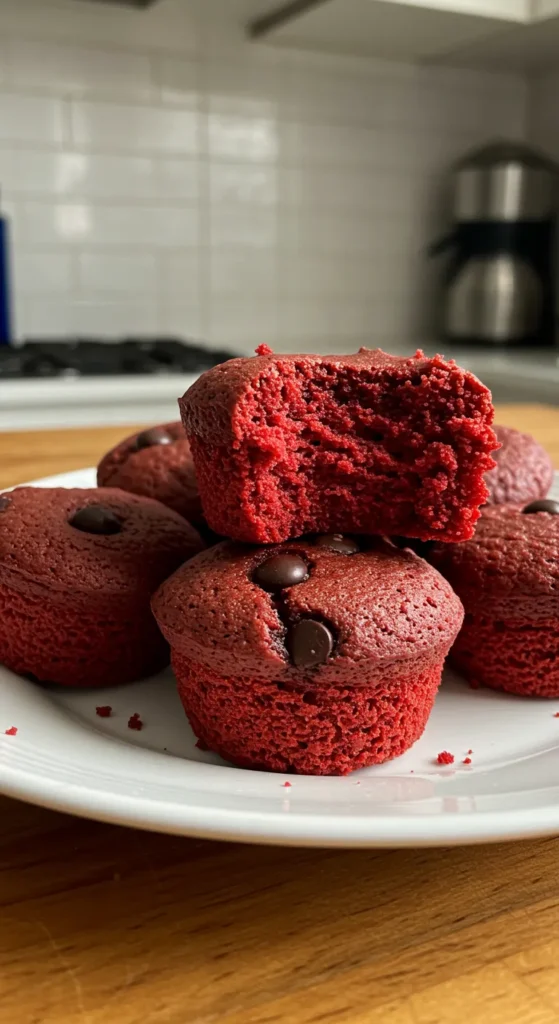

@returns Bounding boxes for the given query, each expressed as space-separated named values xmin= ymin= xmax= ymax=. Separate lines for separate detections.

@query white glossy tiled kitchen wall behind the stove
xmin=0 ymin=0 xmax=528 ymax=350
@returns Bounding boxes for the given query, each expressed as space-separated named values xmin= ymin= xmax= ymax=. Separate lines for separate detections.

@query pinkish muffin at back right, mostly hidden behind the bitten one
xmin=485 ymin=426 xmax=553 ymax=505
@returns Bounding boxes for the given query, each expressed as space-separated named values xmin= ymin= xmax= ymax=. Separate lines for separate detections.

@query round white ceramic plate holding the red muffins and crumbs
xmin=0 ymin=470 xmax=559 ymax=847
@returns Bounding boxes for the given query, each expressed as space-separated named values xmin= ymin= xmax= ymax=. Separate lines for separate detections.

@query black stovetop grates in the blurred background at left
xmin=0 ymin=338 xmax=237 ymax=381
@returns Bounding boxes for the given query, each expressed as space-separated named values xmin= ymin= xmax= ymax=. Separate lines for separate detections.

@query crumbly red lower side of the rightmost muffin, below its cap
xmin=450 ymin=613 xmax=559 ymax=697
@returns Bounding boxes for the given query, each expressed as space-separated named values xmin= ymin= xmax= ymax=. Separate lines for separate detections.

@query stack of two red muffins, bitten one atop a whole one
xmin=146 ymin=349 xmax=497 ymax=774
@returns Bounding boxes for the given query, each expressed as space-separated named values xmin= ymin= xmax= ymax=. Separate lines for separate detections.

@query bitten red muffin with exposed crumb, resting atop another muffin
xmin=179 ymin=347 xmax=497 ymax=544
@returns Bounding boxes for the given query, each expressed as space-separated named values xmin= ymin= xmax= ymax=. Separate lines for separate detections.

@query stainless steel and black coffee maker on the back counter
xmin=431 ymin=142 xmax=557 ymax=345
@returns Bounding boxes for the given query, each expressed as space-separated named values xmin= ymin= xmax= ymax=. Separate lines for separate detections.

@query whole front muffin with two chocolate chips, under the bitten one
xmin=153 ymin=535 xmax=463 ymax=775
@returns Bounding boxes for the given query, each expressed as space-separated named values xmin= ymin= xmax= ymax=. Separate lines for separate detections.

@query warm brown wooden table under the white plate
xmin=0 ymin=406 xmax=559 ymax=1024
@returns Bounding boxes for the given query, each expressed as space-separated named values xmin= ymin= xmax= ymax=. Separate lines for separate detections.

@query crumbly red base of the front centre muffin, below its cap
xmin=172 ymin=652 xmax=442 ymax=775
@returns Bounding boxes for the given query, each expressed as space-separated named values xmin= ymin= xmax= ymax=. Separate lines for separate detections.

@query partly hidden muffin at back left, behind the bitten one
xmin=97 ymin=421 xmax=204 ymax=525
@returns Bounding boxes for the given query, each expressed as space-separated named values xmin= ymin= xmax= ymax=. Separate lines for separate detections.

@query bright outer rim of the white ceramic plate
xmin=0 ymin=467 xmax=559 ymax=849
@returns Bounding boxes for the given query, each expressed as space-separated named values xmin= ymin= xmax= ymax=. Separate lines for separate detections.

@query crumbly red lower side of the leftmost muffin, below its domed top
xmin=0 ymin=585 xmax=169 ymax=686
